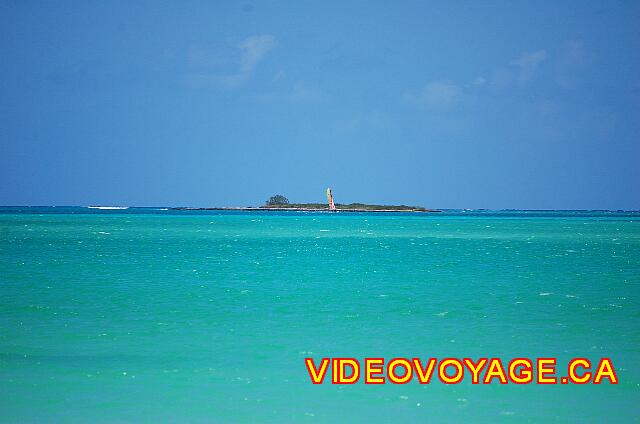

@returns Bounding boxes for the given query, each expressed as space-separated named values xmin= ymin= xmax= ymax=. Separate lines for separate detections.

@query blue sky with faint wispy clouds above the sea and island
xmin=0 ymin=1 xmax=640 ymax=209
